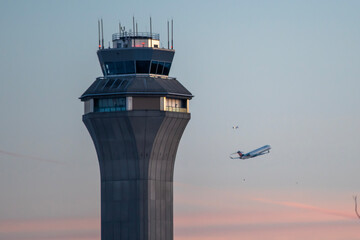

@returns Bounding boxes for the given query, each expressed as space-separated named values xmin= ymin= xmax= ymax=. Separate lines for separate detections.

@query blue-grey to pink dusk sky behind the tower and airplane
xmin=0 ymin=0 xmax=360 ymax=240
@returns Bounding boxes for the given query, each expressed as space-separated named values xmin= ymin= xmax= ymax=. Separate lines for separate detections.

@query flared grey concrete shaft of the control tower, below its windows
xmin=83 ymin=111 xmax=190 ymax=240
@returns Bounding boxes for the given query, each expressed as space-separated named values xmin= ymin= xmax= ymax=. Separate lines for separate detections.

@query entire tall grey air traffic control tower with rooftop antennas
xmin=80 ymin=19 xmax=193 ymax=240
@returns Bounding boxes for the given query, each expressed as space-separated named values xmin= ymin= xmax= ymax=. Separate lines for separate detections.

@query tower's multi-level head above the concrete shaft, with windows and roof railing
xmin=80 ymin=21 xmax=193 ymax=114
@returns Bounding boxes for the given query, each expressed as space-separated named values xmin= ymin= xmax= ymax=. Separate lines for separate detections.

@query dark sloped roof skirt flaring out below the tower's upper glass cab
xmin=80 ymin=75 xmax=193 ymax=101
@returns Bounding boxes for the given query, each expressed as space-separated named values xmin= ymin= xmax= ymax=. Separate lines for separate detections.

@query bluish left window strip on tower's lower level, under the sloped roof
xmin=94 ymin=98 xmax=126 ymax=112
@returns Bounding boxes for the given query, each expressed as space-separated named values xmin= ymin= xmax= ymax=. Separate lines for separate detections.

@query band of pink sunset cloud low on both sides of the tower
xmin=0 ymin=184 xmax=360 ymax=240
